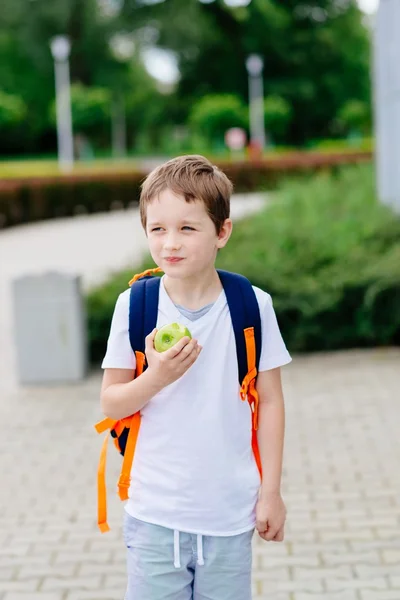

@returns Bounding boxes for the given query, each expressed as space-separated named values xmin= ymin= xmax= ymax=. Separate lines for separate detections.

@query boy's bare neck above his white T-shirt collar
xmin=164 ymin=267 xmax=222 ymax=310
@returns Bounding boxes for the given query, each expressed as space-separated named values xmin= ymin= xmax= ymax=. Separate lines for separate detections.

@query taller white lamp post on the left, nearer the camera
xmin=50 ymin=35 xmax=74 ymax=171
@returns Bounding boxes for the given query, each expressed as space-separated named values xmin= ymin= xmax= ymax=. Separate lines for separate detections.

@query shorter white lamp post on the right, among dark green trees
xmin=246 ymin=54 xmax=265 ymax=150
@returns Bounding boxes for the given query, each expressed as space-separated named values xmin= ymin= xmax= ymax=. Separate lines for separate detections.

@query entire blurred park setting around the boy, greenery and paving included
xmin=0 ymin=0 xmax=400 ymax=600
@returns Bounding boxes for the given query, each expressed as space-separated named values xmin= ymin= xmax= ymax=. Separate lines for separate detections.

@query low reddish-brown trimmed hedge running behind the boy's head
xmin=0 ymin=152 xmax=372 ymax=227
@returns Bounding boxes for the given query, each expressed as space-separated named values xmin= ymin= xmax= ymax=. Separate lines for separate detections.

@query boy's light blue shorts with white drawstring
xmin=124 ymin=514 xmax=254 ymax=600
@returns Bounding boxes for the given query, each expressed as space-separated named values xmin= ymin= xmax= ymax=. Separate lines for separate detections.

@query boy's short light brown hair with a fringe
xmin=140 ymin=154 xmax=233 ymax=233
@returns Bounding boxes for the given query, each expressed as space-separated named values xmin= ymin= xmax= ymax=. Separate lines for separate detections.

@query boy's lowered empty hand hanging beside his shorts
xmin=256 ymin=494 xmax=286 ymax=542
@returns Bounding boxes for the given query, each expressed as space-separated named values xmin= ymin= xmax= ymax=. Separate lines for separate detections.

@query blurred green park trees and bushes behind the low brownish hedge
xmin=0 ymin=0 xmax=377 ymax=163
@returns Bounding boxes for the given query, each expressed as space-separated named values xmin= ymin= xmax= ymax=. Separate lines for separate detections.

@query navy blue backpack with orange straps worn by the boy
xmin=95 ymin=268 xmax=262 ymax=533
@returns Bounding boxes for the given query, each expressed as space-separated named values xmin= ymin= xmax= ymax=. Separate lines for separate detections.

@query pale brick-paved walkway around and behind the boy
xmin=0 ymin=195 xmax=400 ymax=600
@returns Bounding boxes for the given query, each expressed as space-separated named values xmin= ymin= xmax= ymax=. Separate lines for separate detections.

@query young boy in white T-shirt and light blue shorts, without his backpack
xmin=101 ymin=156 xmax=291 ymax=600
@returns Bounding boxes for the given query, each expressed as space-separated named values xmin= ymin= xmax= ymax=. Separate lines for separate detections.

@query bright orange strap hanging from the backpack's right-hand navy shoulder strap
xmin=240 ymin=327 xmax=262 ymax=477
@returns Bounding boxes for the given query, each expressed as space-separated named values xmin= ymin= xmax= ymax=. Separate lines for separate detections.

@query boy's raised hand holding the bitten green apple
xmin=145 ymin=329 xmax=202 ymax=387
